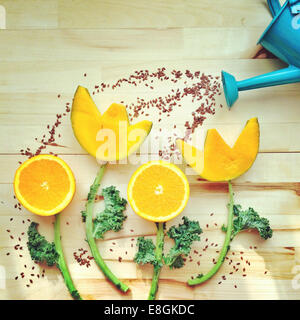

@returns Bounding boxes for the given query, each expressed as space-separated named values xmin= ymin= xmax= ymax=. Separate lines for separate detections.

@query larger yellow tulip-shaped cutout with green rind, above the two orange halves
xmin=71 ymin=86 xmax=152 ymax=162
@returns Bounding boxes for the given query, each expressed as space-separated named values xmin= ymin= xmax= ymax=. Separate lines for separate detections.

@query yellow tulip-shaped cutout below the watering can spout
xmin=176 ymin=118 xmax=260 ymax=181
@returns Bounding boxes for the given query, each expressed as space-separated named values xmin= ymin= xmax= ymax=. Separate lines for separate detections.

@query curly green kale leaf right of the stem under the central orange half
xmin=164 ymin=217 xmax=202 ymax=269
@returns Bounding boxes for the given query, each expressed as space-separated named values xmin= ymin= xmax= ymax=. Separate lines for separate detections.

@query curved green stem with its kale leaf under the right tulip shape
xmin=188 ymin=181 xmax=273 ymax=286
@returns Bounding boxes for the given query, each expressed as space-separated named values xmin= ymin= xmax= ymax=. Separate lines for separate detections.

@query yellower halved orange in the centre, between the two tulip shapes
xmin=127 ymin=160 xmax=190 ymax=222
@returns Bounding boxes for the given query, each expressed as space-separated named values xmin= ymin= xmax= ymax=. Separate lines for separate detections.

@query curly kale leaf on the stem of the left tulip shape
xmin=93 ymin=186 xmax=127 ymax=239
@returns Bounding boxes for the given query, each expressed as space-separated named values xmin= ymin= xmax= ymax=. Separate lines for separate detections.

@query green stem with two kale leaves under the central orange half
xmin=134 ymin=217 xmax=202 ymax=300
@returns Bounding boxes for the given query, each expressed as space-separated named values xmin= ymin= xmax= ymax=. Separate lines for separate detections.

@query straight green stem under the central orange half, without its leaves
xmin=148 ymin=222 xmax=165 ymax=300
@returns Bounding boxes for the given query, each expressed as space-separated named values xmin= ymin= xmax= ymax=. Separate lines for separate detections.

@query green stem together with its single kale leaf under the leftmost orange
xmin=27 ymin=214 xmax=83 ymax=300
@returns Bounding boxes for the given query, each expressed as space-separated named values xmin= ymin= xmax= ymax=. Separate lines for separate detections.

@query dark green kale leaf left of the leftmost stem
xmin=27 ymin=222 xmax=59 ymax=267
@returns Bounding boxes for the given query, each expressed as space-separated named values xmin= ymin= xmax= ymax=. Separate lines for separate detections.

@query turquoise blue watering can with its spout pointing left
xmin=222 ymin=0 xmax=300 ymax=108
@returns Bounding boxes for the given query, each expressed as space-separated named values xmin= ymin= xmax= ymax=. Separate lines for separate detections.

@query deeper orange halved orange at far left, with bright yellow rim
xmin=14 ymin=155 xmax=75 ymax=216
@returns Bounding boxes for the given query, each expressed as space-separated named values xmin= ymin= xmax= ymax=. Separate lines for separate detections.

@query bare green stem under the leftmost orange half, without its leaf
xmin=54 ymin=213 xmax=83 ymax=300
